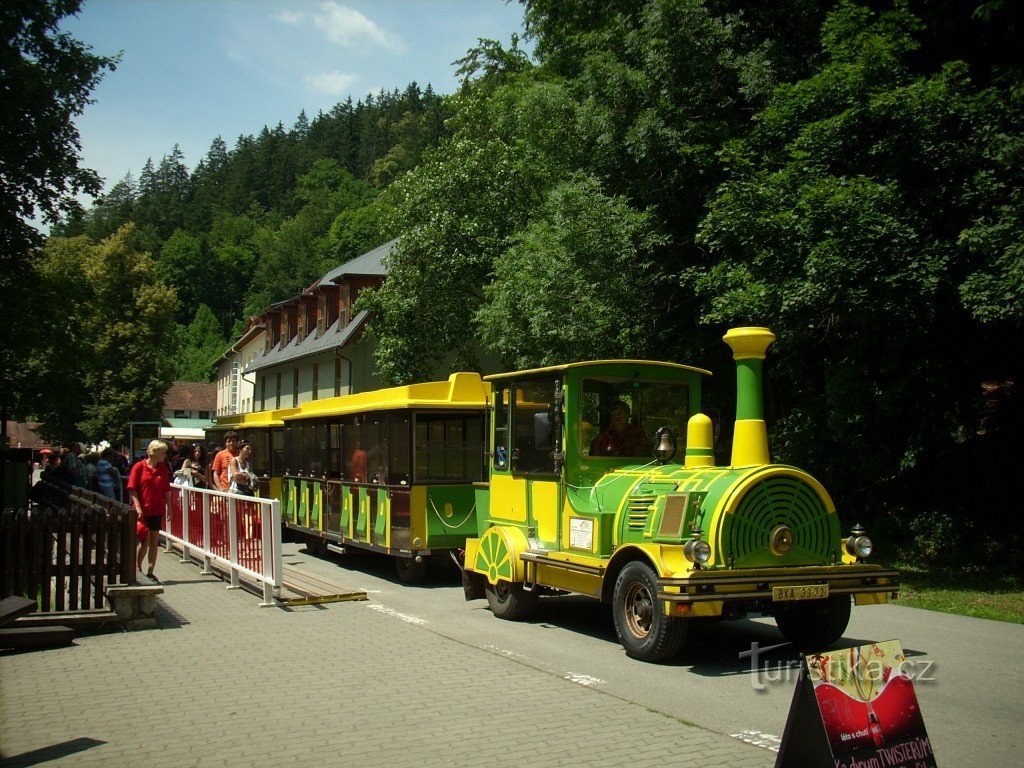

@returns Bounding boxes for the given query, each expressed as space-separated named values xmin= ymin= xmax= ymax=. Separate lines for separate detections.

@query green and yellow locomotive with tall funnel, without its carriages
xmin=463 ymin=328 xmax=899 ymax=660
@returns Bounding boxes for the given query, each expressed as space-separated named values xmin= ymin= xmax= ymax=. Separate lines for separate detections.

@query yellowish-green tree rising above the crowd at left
xmin=27 ymin=224 xmax=176 ymax=441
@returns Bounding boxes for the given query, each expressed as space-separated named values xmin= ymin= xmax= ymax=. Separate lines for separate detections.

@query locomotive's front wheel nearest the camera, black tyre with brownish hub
xmin=611 ymin=561 xmax=689 ymax=662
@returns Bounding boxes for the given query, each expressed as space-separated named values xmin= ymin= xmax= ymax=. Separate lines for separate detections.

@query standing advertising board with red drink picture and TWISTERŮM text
xmin=775 ymin=640 xmax=935 ymax=768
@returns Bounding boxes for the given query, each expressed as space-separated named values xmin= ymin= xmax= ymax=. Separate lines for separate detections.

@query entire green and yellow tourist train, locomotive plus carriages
xmin=205 ymin=328 xmax=899 ymax=660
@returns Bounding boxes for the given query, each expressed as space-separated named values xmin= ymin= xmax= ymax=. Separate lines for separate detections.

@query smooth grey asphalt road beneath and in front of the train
xmin=288 ymin=545 xmax=1024 ymax=767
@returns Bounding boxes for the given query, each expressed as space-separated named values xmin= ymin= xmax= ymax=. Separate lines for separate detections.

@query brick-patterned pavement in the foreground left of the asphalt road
xmin=0 ymin=553 xmax=775 ymax=768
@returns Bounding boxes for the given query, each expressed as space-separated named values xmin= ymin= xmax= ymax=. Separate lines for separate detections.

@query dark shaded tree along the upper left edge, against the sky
xmin=0 ymin=0 xmax=117 ymax=431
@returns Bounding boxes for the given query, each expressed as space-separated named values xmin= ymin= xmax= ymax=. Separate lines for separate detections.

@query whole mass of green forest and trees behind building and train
xmin=16 ymin=0 xmax=1024 ymax=567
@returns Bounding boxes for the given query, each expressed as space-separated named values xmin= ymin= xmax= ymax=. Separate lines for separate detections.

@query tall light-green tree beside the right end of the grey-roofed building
xmin=359 ymin=78 xmax=581 ymax=382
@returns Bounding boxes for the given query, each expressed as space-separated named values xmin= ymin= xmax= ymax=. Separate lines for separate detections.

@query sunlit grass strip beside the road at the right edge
xmin=895 ymin=563 xmax=1024 ymax=624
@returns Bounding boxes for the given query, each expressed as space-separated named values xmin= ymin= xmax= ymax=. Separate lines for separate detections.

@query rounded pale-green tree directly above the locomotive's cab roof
xmin=476 ymin=177 xmax=670 ymax=368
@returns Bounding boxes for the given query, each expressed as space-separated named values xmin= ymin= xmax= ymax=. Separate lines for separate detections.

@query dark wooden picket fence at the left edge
xmin=0 ymin=481 xmax=138 ymax=612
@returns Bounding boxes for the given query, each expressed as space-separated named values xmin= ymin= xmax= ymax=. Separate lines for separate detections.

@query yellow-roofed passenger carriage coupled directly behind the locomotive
xmin=281 ymin=373 xmax=490 ymax=583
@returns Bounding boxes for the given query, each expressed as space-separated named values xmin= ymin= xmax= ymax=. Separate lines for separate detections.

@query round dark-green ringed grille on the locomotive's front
xmin=719 ymin=476 xmax=842 ymax=567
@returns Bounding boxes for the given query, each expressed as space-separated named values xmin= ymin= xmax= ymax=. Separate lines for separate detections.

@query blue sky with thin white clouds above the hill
xmin=61 ymin=0 xmax=522 ymax=198
